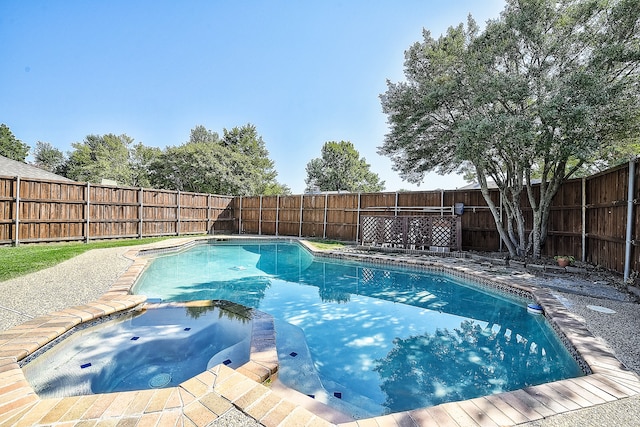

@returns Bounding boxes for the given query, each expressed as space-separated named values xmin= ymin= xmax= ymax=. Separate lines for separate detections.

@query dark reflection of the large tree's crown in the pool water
xmin=374 ymin=320 xmax=551 ymax=412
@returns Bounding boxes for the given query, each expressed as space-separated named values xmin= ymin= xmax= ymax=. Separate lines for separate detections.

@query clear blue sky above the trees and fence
xmin=0 ymin=0 xmax=504 ymax=193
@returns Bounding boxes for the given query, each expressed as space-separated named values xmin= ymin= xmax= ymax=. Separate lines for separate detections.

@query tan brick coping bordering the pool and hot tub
xmin=0 ymin=236 xmax=640 ymax=427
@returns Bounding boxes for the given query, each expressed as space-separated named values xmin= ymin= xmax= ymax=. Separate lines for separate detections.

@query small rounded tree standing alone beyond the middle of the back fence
xmin=305 ymin=141 xmax=384 ymax=192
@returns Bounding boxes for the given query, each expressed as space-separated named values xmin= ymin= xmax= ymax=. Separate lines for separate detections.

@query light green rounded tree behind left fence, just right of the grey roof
xmin=66 ymin=133 xmax=133 ymax=185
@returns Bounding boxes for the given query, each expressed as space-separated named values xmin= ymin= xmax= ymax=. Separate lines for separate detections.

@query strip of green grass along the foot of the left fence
xmin=0 ymin=237 xmax=176 ymax=282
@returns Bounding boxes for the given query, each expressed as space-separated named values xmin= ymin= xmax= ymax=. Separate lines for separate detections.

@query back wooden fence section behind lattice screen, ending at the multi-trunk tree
xmin=234 ymin=190 xmax=500 ymax=250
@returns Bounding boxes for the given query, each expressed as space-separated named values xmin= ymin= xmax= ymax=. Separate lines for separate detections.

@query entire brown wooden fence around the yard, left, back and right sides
xmin=0 ymin=159 xmax=640 ymax=277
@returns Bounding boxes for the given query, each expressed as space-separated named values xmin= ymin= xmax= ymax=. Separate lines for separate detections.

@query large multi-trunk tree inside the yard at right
xmin=379 ymin=0 xmax=640 ymax=258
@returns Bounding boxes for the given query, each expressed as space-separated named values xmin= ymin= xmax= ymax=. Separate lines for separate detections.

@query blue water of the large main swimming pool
xmin=134 ymin=243 xmax=582 ymax=417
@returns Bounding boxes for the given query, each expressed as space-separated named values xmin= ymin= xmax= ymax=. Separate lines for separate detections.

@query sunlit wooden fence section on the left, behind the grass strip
xmin=0 ymin=177 xmax=234 ymax=244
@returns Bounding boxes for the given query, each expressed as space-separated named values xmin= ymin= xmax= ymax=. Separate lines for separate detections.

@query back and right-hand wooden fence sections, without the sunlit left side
xmin=234 ymin=159 xmax=640 ymax=273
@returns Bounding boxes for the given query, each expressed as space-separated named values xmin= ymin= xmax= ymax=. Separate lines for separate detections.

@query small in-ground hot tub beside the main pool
xmin=22 ymin=301 xmax=253 ymax=398
